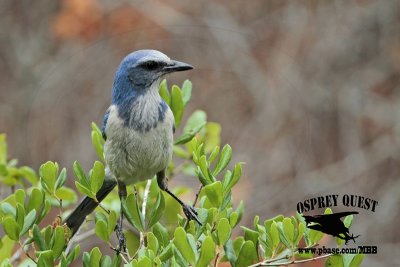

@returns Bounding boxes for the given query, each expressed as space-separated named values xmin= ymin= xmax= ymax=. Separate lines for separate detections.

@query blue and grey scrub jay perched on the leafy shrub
xmin=65 ymin=49 xmax=200 ymax=251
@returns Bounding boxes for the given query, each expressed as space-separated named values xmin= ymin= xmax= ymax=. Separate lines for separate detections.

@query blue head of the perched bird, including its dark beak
xmin=112 ymin=50 xmax=193 ymax=105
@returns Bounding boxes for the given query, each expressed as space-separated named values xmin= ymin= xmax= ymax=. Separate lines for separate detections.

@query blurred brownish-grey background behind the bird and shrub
xmin=0 ymin=0 xmax=400 ymax=266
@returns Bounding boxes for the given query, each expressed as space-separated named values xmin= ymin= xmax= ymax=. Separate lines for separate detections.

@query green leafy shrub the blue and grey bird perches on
xmin=0 ymin=81 xmax=362 ymax=267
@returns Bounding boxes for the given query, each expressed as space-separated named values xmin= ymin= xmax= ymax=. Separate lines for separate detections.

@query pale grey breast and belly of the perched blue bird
xmin=104 ymin=101 xmax=174 ymax=184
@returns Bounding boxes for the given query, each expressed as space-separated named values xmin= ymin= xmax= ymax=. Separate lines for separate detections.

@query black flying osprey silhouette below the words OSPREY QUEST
xmin=303 ymin=211 xmax=360 ymax=245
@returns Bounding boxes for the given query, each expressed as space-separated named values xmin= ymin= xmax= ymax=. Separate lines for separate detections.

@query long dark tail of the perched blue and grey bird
xmin=64 ymin=179 xmax=117 ymax=236
